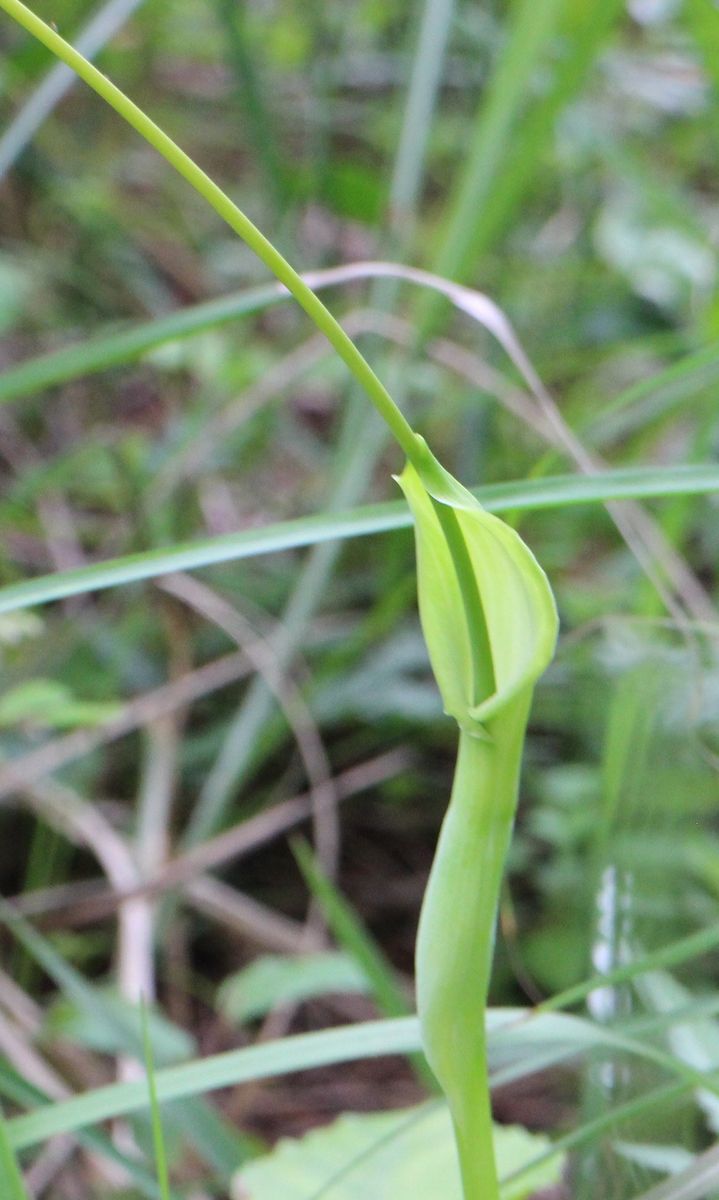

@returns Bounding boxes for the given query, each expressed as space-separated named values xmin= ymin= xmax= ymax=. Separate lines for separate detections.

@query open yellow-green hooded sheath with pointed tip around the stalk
xmin=397 ymin=451 xmax=558 ymax=736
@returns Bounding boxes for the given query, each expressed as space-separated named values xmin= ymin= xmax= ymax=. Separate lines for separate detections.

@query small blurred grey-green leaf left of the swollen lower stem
xmin=218 ymin=950 xmax=369 ymax=1022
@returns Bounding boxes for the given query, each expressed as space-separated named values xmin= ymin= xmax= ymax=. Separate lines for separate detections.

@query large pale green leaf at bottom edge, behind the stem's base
xmin=232 ymin=1104 xmax=562 ymax=1200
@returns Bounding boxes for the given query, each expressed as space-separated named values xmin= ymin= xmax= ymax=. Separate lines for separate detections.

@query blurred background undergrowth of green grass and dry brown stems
xmin=0 ymin=0 xmax=719 ymax=1200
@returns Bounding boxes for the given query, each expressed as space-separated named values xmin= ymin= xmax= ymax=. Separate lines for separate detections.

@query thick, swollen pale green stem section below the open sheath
xmin=417 ymin=690 xmax=531 ymax=1200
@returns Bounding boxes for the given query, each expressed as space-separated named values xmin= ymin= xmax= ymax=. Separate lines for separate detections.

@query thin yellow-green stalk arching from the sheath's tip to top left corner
xmin=0 ymin=0 xmax=415 ymax=458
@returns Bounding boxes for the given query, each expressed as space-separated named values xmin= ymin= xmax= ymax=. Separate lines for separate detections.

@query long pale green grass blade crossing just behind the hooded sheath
xmin=0 ymin=463 xmax=719 ymax=613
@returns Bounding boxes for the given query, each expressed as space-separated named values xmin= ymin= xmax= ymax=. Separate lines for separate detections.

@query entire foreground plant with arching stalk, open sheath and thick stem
xmin=0 ymin=0 xmax=557 ymax=1200
